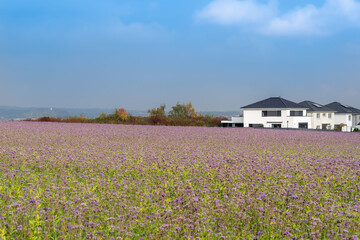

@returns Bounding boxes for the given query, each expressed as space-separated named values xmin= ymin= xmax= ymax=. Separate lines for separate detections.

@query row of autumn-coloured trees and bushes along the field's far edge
xmin=38 ymin=102 xmax=226 ymax=127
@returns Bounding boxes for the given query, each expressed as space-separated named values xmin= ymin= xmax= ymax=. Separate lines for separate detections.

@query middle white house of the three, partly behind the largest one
xmin=299 ymin=101 xmax=335 ymax=130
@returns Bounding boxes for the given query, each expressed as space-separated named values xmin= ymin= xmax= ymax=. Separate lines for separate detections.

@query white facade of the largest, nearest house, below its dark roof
xmin=244 ymin=108 xmax=312 ymax=129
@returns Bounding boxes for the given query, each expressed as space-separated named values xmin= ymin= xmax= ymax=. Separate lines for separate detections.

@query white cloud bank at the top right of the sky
xmin=196 ymin=0 xmax=360 ymax=35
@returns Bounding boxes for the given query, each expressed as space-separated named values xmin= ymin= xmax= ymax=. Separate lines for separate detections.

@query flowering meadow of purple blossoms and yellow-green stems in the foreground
xmin=0 ymin=122 xmax=360 ymax=239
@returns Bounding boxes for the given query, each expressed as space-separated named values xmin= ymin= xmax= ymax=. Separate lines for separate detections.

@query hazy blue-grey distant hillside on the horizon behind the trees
xmin=0 ymin=106 xmax=242 ymax=120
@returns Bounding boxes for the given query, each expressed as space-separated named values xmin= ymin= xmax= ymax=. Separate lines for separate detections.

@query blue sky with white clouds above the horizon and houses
xmin=0 ymin=0 xmax=360 ymax=111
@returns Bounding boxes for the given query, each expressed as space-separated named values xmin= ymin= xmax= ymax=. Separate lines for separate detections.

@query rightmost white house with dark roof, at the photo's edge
xmin=325 ymin=102 xmax=360 ymax=132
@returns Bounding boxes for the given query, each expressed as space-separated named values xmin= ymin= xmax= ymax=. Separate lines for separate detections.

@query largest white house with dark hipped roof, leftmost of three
xmin=242 ymin=97 xmax=312 ymax=129
